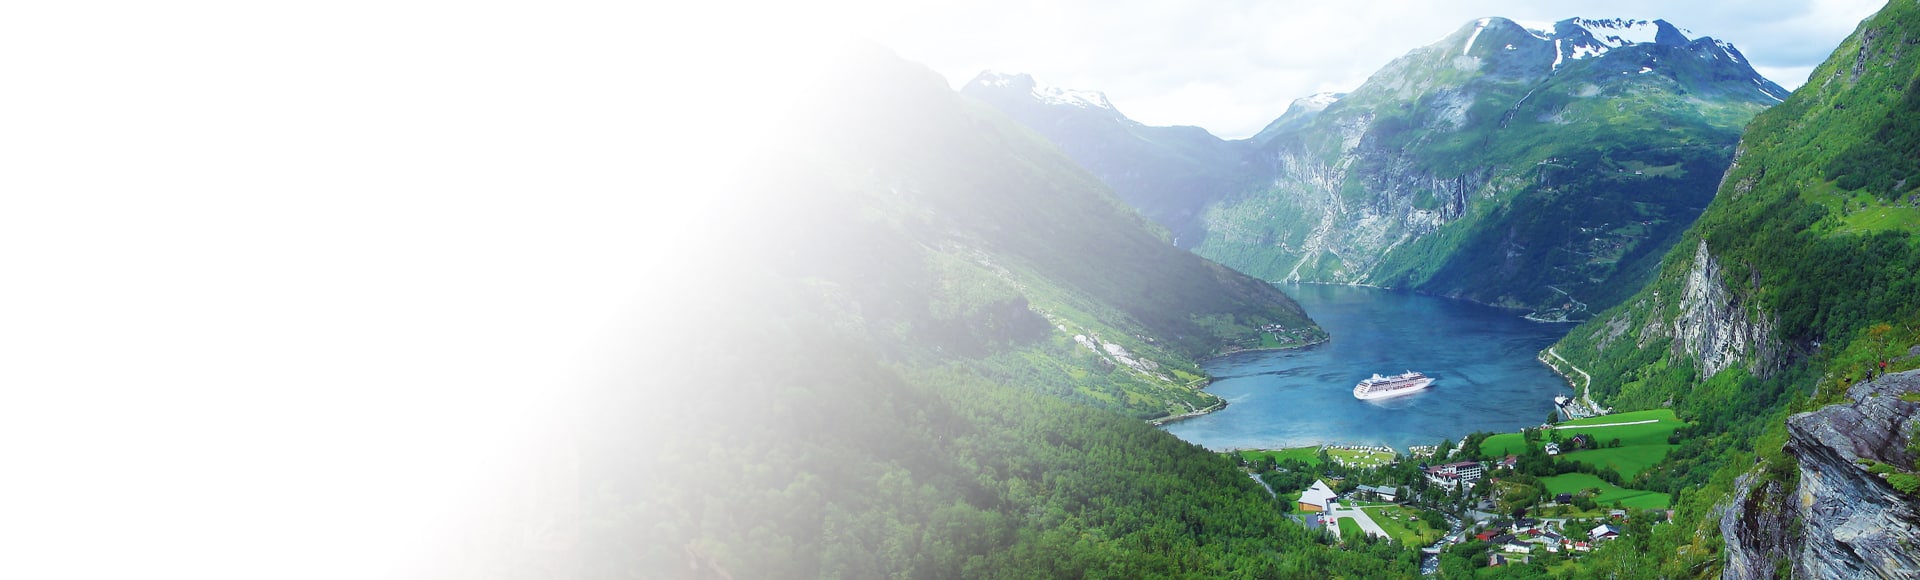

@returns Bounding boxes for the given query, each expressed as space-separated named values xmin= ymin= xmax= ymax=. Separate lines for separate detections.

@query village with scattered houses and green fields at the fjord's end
xmin=1231 ymin=411 xmax=1680 ymax=572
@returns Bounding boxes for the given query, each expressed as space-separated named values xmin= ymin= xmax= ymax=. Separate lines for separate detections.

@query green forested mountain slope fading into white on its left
xmin=559 ymin=50 xmax=1417 ymax=578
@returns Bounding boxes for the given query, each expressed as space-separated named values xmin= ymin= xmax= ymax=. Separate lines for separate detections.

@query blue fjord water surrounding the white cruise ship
xmin=1165 ymin=284 xmax=1572 ymax=451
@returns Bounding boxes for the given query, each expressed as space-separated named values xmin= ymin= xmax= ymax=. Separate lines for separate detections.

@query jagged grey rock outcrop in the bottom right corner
xmin=1720 ymin=371 xmax=1920 ymax=578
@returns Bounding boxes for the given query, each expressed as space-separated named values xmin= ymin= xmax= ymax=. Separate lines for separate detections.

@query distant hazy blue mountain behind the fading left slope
xmin=960 ymin=71 xmax=1261 ymax=248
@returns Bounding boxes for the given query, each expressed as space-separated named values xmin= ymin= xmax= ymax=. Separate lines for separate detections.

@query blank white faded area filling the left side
xmin=0 ymin=2 xmax=833 ymax=578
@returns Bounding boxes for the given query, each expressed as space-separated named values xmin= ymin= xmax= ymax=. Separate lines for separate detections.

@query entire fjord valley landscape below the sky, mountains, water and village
xmin=541 ymin=0 xmax=1920 ymax=578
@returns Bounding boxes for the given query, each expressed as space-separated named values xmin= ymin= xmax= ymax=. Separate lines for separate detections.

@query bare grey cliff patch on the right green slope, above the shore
xmin=1672 ymin=240 xmax=1782 ymax=376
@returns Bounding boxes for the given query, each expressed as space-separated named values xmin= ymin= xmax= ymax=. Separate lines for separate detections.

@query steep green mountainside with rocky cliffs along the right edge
xmin=1551 ymin=0 xmax=1920 ymax=578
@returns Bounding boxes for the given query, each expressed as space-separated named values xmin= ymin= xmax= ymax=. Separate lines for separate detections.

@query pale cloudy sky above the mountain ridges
xmin=847 ymin=0 xmax=1885 ymax=138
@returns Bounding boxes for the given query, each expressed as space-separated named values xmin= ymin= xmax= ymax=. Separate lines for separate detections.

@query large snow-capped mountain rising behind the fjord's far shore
xmin=1194 ymin=17 xmax=1788 ymax=319
